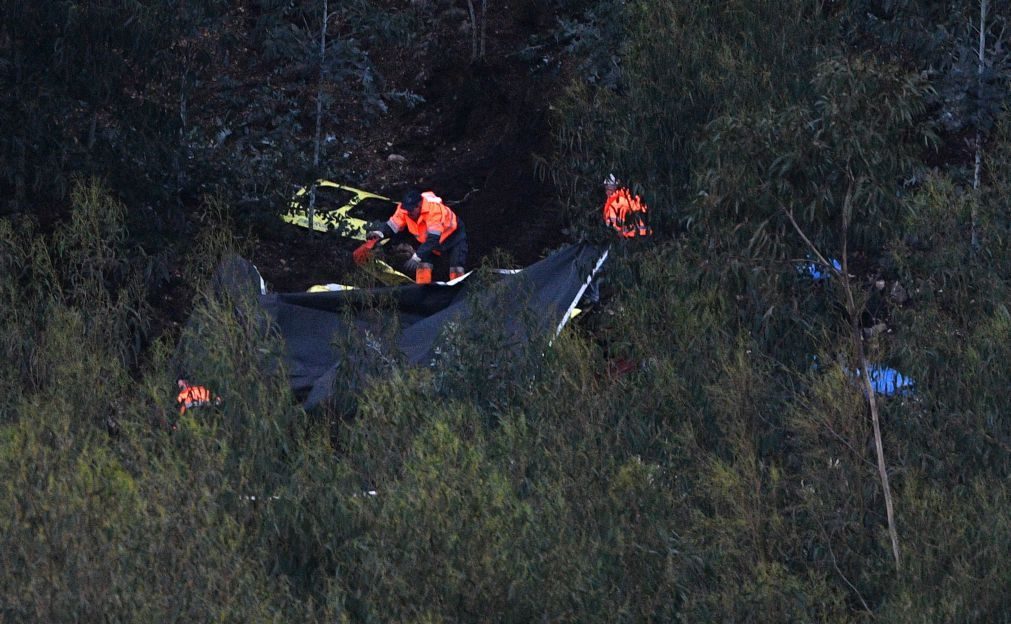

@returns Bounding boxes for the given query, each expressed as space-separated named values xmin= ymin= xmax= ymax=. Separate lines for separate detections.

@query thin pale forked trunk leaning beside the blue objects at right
xmin=779 ymin=181 xmax=902 ymax=570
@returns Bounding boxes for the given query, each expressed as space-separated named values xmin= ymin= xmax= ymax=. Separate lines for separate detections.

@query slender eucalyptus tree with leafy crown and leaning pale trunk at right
xmin=695 ymin=56 xmax=933 ymax=565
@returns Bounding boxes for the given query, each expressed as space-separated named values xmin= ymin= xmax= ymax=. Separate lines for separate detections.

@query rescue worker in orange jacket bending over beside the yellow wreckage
xmin=367 ymin=190 xmax=467 ymax=283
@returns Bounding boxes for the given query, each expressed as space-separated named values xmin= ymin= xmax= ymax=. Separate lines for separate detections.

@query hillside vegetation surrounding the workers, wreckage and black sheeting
xmin=0 ymin=0 xmax=1011 ymax=623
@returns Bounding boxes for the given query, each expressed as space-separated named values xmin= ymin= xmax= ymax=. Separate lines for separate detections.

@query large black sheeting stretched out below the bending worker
xmin=245 ymin=244 xmax=606 ymax=409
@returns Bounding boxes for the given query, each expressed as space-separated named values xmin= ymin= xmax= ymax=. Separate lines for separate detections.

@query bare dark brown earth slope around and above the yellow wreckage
xmin=252 ymin=1 xmax=564 ymax=291
